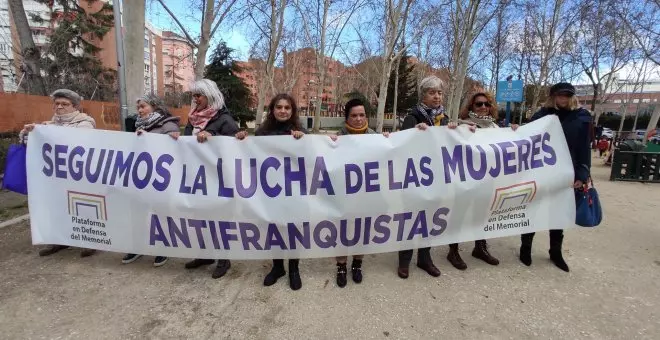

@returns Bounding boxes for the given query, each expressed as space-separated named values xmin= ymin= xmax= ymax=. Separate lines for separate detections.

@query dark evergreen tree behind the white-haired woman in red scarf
xmin=204 ymin=41 xmax=255 ymax=127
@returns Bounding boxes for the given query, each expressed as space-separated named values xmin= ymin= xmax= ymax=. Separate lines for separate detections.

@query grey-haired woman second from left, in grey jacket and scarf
xmin=121 ymin=94 xmax=179 ymax=267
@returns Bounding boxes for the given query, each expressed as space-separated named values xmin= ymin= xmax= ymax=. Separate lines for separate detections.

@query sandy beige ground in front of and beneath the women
xmin=0 ymin=155 xmax=660 ymax=339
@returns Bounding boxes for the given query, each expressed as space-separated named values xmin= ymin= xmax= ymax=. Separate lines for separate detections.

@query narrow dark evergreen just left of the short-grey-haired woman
xmin=385 ymin=56 xmax=417 ymax=113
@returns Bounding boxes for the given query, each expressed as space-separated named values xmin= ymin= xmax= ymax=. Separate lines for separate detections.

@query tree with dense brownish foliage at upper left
xmin=31 ymin=0 xmax=116 ymax=100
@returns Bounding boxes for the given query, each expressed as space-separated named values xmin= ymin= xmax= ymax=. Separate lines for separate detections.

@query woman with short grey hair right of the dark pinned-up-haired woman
xmin=397 ymin=76 xmax=448 ymax=279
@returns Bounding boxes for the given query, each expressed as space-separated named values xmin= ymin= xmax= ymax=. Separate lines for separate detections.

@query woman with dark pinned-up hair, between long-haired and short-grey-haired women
xmin=330 ymin=98 xmax=389 ymax=288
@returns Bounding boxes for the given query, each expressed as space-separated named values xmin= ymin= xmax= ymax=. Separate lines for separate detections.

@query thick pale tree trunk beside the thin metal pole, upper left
xmin=124 ymin=0 xmax=145 ymax=114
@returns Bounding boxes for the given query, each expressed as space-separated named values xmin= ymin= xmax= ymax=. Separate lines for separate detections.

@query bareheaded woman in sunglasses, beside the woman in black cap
xmin=447 ymin=92 xmax=518 ymax=270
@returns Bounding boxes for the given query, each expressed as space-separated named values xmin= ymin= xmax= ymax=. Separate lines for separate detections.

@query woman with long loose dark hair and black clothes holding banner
xmin=236 ymin=93 xmax=307 ymax=290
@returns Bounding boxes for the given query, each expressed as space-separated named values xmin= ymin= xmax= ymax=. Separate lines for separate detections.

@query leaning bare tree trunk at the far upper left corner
xmin=9 ymin=0 xmax=48 ymax=96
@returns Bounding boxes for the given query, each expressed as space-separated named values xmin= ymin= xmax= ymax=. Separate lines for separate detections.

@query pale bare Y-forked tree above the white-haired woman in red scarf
xmin=157 ymin=0 xmax=237 ymax=80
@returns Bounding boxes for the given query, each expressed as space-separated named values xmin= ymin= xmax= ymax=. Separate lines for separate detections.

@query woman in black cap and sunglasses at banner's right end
xmin=520 ymin=83 xmax=591 ymax=272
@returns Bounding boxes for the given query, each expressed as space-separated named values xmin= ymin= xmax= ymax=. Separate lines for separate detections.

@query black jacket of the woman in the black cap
xmin=531 ymin=107 xmax=591 ymax=182
